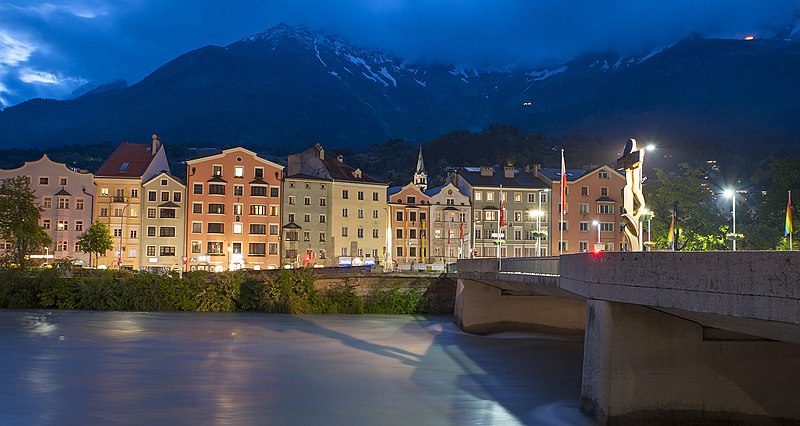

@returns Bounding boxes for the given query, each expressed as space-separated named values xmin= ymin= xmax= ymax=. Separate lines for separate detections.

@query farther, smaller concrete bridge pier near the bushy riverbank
xmin=454 ymin=279 xmax=586 ymax=334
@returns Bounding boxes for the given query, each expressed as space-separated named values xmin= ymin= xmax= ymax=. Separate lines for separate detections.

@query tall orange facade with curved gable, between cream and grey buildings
xmin=186 ymin=147 xmax=283 ymax=271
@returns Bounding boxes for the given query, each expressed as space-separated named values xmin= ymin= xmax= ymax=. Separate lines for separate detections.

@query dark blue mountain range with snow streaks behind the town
xmin=0 ymin=24 xmax=800 ymax=155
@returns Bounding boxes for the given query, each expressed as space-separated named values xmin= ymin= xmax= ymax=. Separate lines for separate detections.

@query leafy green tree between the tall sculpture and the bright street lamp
xmin=644 ymin=163 xmax=727 ymax=250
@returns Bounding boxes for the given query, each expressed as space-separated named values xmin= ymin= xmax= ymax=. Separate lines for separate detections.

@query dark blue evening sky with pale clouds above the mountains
xmin=0 ymin=0 xmax=800 ymax=107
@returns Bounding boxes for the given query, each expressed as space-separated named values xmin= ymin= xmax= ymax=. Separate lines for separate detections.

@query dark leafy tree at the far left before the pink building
xmin=0 ymin=176 xmax=53 ymax=266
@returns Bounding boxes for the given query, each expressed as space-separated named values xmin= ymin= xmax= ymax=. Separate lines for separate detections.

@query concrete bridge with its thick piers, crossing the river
xmin=455 ymin=251 xmax=800 ymax=424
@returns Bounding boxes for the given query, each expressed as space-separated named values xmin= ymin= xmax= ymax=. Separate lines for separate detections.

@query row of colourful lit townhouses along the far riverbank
xmin=0 ymin=135 xmax=625 ymax=271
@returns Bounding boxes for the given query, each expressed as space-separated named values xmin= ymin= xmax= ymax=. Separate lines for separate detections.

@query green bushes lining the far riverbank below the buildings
xmin=0 ymin=268 xmax=427 ymax=314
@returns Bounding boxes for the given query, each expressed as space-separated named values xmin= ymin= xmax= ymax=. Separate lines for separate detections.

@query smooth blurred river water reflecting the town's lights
xmin=0 ymin=311 xmax=590 ymax=425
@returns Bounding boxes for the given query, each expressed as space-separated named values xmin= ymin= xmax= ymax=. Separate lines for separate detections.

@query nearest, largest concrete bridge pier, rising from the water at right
xmin=580 ymin=300 xmax=800 ymax=424
